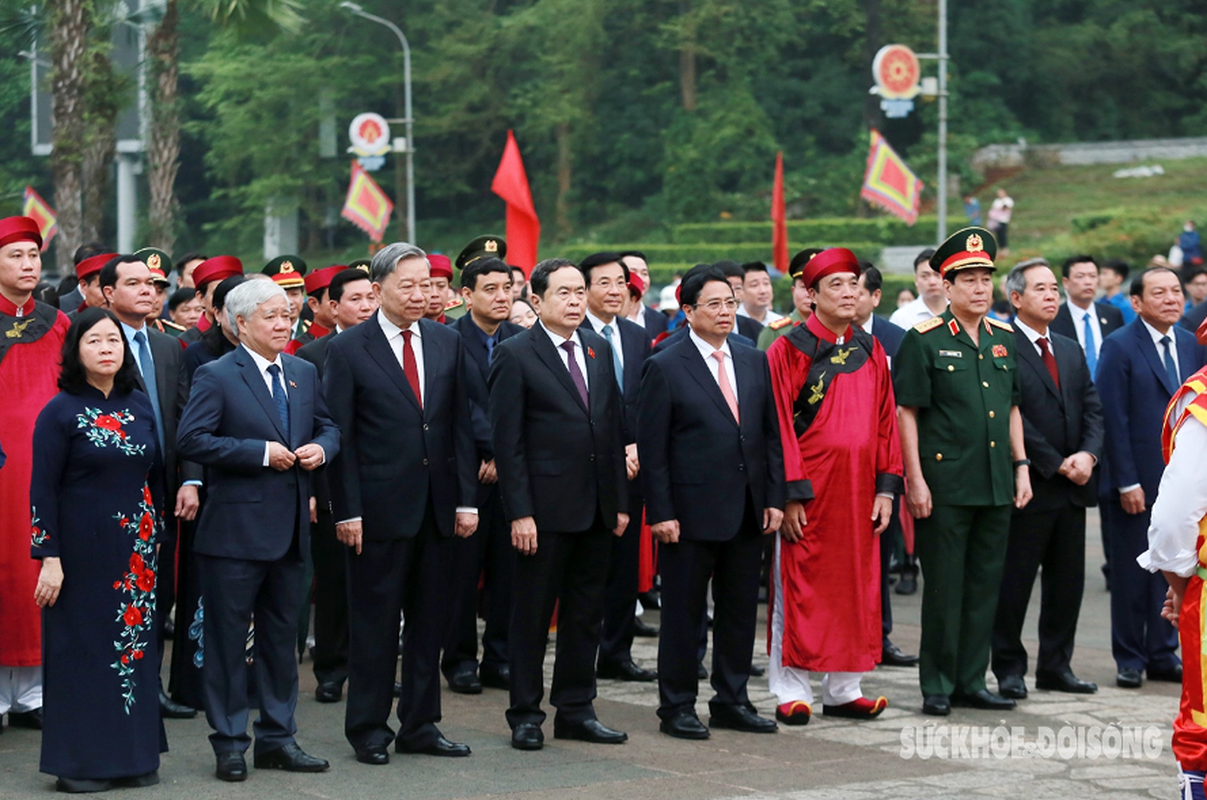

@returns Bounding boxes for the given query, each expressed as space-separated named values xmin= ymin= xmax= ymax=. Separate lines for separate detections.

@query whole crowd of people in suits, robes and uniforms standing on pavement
xmin=0 ymin=212 xmax=1207 ymax=792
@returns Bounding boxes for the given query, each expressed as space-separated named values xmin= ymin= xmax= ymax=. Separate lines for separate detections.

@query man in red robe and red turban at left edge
xmin=0 ymin=217 xmax=70 ymax=728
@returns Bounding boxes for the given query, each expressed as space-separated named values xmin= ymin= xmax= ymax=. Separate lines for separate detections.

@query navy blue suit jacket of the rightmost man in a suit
xmin=1097 ymin=317 xmax=1207 ymax=494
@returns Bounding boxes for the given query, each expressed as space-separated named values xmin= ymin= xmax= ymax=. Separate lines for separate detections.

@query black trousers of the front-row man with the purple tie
xmin=507 ymin=523 xmax=616 ymax=729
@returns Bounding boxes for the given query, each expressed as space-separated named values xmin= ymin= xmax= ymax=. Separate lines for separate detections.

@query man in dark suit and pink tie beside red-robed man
xmin=637 ymin=267 xmax=785 ymax=738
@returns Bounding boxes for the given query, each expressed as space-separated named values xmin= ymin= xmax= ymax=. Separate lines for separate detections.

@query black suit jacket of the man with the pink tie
xmin=637 ymin=337 xmax=785 ymax=541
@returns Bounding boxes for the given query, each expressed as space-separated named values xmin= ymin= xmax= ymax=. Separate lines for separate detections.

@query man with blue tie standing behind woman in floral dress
xmin=97 ymin=256 xmax=202 ymax=719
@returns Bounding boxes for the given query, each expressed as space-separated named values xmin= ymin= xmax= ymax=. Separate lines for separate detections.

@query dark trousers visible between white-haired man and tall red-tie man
xmin=310 ymin=508 xmax=348 ymax=685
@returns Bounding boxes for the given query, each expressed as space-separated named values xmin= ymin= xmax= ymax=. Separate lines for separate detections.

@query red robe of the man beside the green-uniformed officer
xmin=766 ymin=315 xmax=903 ymax=672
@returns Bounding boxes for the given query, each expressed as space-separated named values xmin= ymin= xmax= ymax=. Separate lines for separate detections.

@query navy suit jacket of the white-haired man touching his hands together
xmin=179 ymin=348 xmax=339 ymax=561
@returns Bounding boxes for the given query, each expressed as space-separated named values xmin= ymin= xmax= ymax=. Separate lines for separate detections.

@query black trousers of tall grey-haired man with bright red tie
xmin=344 ymin=503 xmax=449 ymax=749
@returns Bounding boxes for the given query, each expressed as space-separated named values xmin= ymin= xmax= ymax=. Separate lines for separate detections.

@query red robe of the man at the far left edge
xmin=0 ymin=296 xmax=71 ymax=667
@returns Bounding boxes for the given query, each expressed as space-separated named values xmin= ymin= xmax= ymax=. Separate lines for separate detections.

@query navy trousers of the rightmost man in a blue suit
xmin=1100 ymin=491 xmax=1182 ymax=670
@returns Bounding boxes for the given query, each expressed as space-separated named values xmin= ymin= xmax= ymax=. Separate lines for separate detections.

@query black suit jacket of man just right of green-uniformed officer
xmin=1014 ymin=328 xmax=1103 ymax=513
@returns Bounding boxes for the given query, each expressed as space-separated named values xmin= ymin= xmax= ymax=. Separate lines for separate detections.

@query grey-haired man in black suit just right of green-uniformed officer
xmin=992 ymin=258 xmax=1103 ymax=700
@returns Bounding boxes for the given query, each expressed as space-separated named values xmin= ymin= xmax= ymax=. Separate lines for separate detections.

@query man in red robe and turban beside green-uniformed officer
xmin=766 ymin=247 xmax=904 ymax=725
